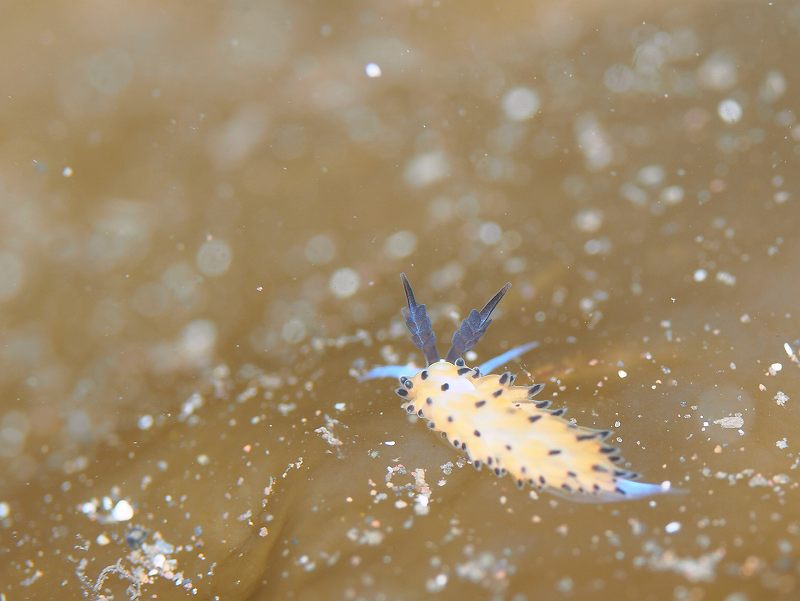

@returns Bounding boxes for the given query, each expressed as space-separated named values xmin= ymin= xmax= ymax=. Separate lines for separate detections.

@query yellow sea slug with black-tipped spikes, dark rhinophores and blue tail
xmin=361 ymin=274 xmax=670 ymax=502
